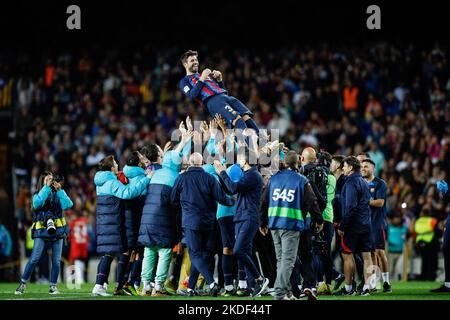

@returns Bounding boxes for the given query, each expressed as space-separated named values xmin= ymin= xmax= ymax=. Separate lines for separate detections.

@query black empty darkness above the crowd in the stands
xmin=0 ymin=0 xmax=450 ymax=52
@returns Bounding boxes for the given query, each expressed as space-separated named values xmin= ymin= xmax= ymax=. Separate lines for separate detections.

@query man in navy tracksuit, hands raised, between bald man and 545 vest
xmin=214 ymin=150 xmax=269 ymax=297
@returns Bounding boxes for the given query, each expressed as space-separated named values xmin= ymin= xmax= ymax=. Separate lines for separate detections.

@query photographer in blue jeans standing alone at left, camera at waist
xmin=15 ymin=171 xmax=73 ymax=294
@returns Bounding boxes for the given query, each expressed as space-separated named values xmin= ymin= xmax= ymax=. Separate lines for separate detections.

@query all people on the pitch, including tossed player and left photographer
xmin=11 ymin=51 xmax=448 ymax=300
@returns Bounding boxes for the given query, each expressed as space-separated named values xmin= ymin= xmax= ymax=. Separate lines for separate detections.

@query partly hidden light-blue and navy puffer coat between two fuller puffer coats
xmin=123 ymin=166 xmax=147 ymax=249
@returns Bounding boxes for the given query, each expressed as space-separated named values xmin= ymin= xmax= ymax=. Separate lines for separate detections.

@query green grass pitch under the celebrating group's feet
xmin=0 ymin=281 xmax=450 ymax=301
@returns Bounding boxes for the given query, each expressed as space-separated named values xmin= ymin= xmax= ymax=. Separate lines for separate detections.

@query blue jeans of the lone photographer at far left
xmin=21 ymin=238 xmax=63 ymax=285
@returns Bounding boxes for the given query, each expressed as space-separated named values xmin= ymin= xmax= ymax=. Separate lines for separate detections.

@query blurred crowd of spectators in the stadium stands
xmin=9 ymin=43 xmax=450 ymax=282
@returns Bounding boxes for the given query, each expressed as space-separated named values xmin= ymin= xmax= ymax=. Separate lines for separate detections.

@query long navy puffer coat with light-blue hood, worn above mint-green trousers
xmin=138 ymin=151 xmax=182 ymax=248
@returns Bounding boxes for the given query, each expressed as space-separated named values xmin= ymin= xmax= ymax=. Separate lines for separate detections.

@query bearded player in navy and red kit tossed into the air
xmin=179 ymin=50 xmax=259 ymax=133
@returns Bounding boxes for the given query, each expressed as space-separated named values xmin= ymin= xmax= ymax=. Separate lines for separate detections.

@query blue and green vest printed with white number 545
xmin=267 ymin=169 xmax=308 ymax=231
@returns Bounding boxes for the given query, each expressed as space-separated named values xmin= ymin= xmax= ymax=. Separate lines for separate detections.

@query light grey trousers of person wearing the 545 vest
xmin=271 ymin=229 xmax=300 ymax=299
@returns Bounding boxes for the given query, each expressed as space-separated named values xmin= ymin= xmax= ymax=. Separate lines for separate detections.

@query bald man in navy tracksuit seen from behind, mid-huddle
xmin=170 ymin=153 xmax=234 ymax=296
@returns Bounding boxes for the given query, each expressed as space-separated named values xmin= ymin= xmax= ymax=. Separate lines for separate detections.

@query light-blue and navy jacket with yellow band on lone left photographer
xmin=31 ymin=185 xmax=73 ymax=240
